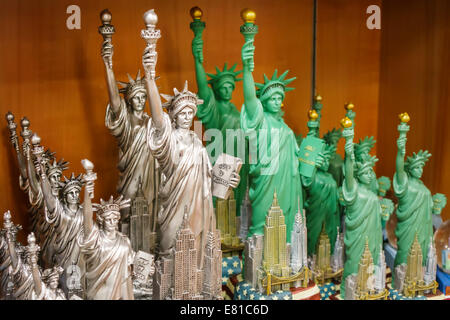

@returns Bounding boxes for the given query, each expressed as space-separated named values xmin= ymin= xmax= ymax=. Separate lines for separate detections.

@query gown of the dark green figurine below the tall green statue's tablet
xmin=303 ymin=169 xmax=341 ymax=256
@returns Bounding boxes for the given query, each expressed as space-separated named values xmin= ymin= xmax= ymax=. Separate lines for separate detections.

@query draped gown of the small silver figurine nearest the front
xmin=78 ymin=224 xmax=134 ymax=300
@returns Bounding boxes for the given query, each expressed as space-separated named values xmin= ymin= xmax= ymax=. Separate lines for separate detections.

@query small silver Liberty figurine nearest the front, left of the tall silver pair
xmin=78 ymin=160 xmax=134 ymax=300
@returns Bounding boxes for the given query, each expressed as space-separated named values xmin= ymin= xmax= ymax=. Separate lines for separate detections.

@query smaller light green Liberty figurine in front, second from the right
xmin=341 ymin=117 xmax=383 ymax=298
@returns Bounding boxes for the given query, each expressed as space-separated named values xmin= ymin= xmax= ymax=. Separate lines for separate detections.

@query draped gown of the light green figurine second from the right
xmin=341 ymin=179 xmax=383 ymax=297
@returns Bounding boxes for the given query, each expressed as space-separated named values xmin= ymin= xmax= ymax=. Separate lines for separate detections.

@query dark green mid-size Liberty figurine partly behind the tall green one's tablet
xmin=301 ymin=109 xmax=341 ymax=256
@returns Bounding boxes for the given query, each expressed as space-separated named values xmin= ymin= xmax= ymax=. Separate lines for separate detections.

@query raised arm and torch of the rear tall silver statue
xmin=98 ymin=9 xmax=120 ymax=114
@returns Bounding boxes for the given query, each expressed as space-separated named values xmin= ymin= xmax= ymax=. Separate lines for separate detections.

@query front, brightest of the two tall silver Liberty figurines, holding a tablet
xmin=142 ymin=10 xmax=239 ymax=269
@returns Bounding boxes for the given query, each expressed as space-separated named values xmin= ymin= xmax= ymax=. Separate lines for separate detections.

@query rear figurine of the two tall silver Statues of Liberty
xmin=99 ymin=9 xmax=158 ymax=234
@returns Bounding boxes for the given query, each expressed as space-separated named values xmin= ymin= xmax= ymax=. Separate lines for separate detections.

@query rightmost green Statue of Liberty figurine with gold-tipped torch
xmin=393 ymin=112 xmax=433 ymax=283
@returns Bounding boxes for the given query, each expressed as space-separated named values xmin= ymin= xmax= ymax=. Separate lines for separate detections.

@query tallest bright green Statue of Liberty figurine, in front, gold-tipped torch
xmin=240 ymin=9 xmax=303 ymax=241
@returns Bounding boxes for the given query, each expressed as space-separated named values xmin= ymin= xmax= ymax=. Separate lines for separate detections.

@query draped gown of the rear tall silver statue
xmin=105 ymin=97 xmax=155 ymax=212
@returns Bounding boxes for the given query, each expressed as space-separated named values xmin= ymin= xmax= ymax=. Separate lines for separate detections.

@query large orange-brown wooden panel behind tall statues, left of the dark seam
xmin=0 ymin=0 xmax=312 ymax=239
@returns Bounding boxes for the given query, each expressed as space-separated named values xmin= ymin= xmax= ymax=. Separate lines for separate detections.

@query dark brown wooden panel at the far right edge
xmin=378 ymin=0 xmax=450 ymax=219
